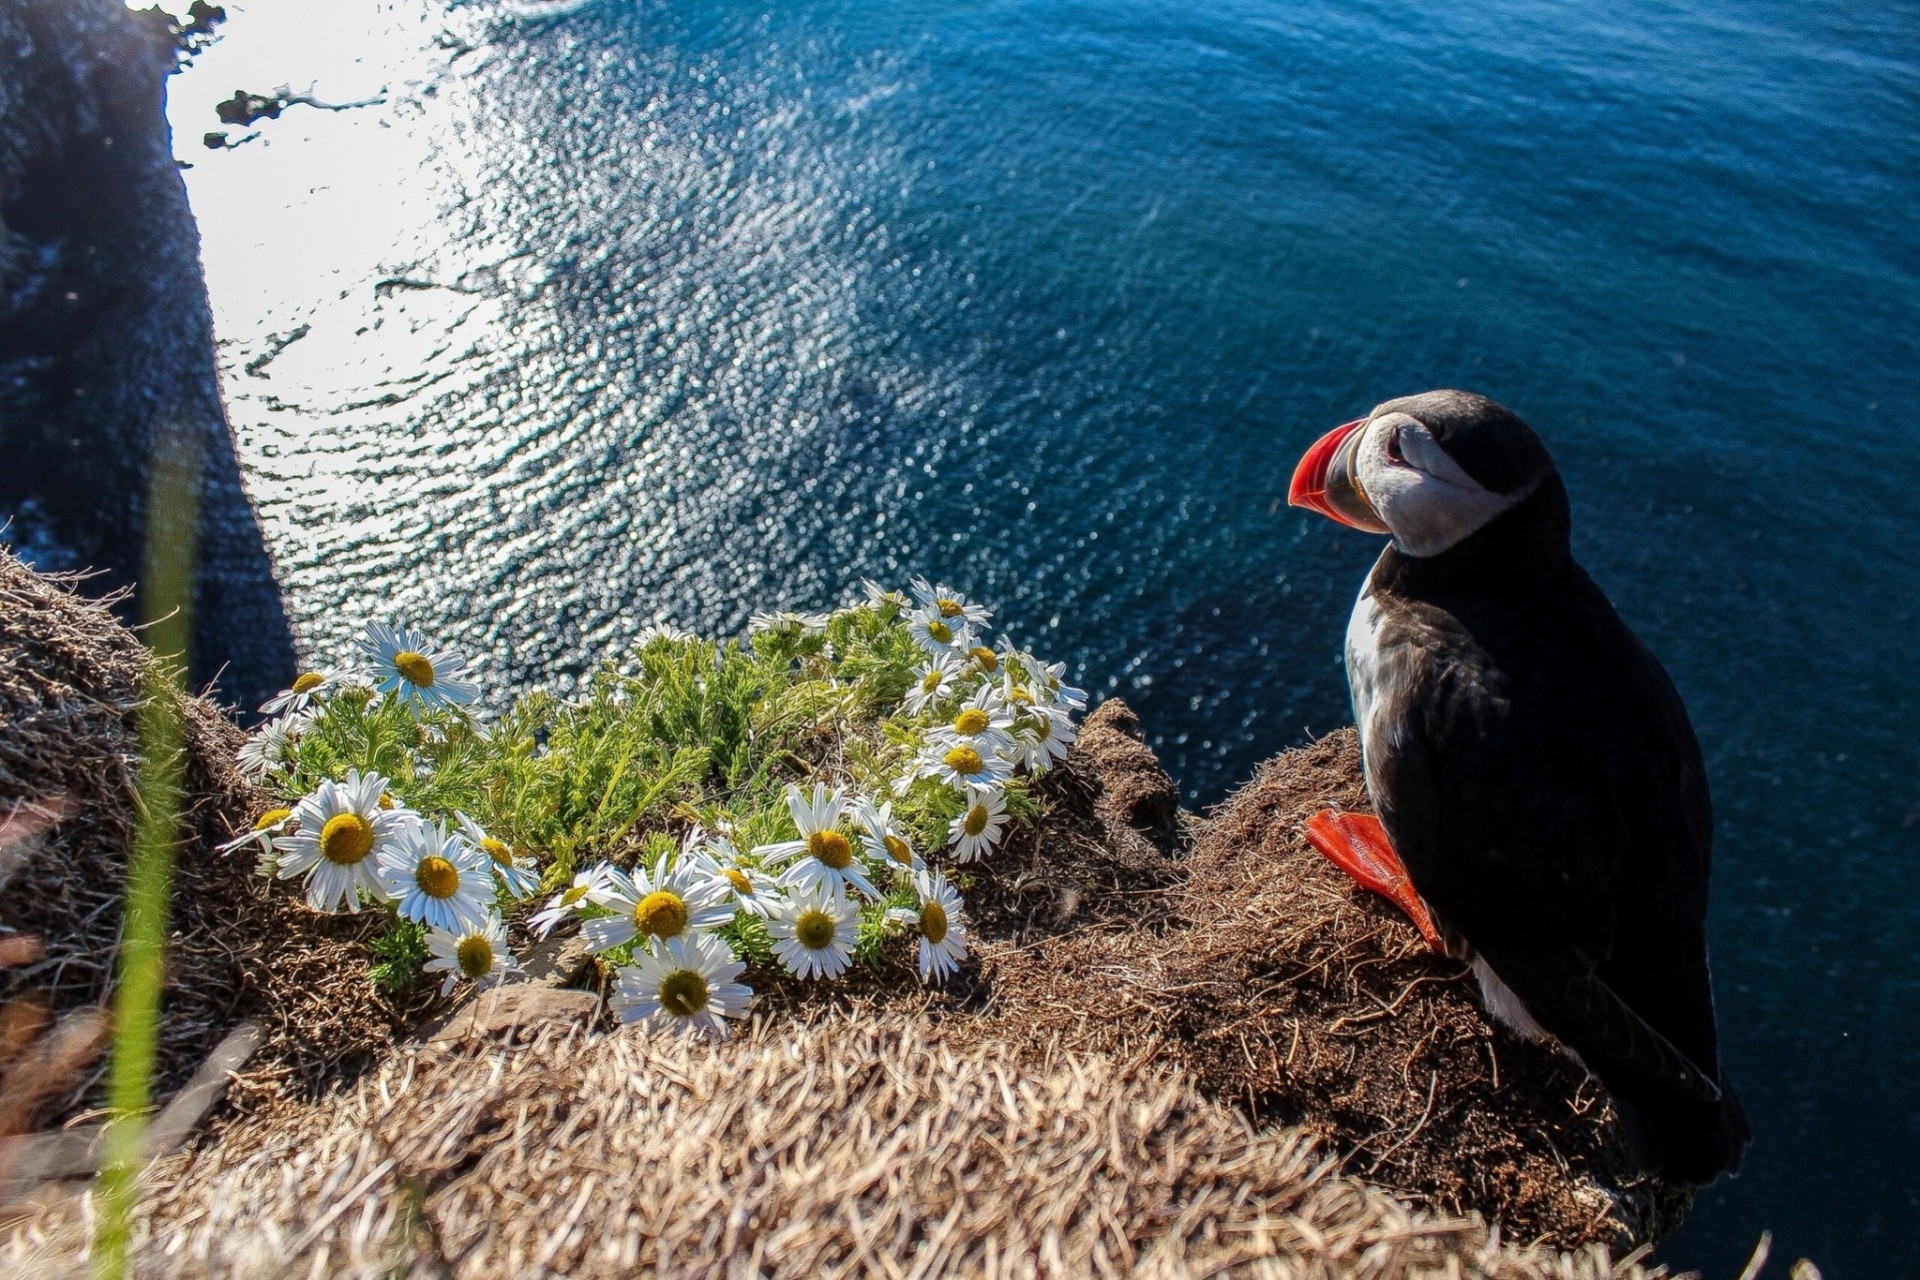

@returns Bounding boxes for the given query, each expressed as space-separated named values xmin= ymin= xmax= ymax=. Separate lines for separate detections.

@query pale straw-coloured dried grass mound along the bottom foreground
xmin=0 ymin=1017 xmax=1666 ymax=1280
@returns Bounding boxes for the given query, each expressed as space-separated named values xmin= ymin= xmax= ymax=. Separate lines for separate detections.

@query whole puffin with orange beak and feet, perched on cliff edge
xmin=1288 ymin=391 xmax=1749 ymax=1186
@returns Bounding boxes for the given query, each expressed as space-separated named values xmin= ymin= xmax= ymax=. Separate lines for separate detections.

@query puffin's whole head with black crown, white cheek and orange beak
xmin=1286 ymin=391 xmax=1557 ymax=557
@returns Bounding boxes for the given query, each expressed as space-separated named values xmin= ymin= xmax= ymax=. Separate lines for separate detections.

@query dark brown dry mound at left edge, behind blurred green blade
xmin=0 ymin=549 xmax=432 ymax=1119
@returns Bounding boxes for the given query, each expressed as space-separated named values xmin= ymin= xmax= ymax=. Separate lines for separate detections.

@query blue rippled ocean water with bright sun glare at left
xmin=175 ymin=0 xmax=1920 ymax=1280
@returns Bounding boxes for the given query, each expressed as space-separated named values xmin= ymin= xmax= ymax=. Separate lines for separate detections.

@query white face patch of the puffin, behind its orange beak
xmin=1352 ymin=413 xmax=1538 ymax=557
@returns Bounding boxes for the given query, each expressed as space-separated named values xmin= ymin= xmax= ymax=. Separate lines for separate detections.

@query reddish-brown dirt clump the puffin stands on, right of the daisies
xmin=929 ymin=702 xmax=1690 ymax=1247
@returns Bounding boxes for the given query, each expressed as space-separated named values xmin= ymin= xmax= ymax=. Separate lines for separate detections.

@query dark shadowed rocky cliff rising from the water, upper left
xmin=0 ymin=0 xmax=294 ymax=706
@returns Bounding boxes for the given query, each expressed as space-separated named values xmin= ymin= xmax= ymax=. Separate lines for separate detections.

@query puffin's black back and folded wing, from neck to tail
xmin=1367 ymin=562 xmax=1745 ymax=1180
